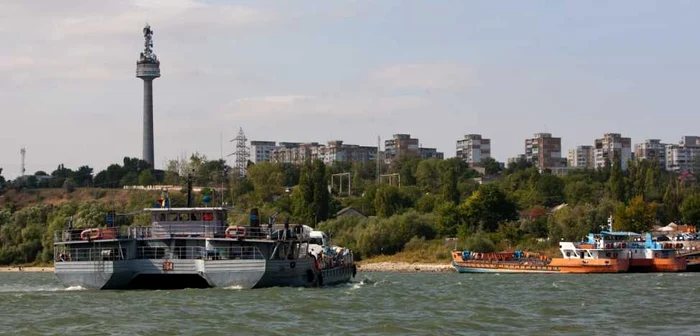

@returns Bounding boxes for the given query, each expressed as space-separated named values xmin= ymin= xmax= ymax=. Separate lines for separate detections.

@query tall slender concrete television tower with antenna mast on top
xmin=136 ymin=24 xmax=160 ymax=168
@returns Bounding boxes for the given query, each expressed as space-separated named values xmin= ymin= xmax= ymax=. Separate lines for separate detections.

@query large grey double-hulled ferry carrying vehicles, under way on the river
xmin=54 ymin=203 xmax=356 ymax=289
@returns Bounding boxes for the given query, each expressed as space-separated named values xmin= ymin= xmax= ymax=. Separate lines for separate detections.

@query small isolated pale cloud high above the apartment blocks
xmin=370 ymin=63 xmax=479 ymax=91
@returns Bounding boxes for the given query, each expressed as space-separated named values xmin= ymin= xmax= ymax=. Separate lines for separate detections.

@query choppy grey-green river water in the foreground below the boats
xmin=0 ymin=273 xmax=700 ymax=335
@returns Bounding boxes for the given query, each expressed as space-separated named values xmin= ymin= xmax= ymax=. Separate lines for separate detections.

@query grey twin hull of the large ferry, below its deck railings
xmin=55 ymin=258 xmax=355 ymax=289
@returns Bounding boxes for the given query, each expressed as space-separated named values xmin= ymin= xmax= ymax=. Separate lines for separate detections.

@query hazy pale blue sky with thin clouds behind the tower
xmin=0 ymin=0 xmax=700 ymax=178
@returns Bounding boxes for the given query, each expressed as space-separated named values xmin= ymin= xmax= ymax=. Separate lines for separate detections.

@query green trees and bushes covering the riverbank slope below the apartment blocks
xmin=0 ymin=154 xmax=700 ymax=264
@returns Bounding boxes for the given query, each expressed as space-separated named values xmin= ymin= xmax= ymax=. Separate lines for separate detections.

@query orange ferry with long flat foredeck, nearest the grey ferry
xmin=452 ymin=238 xmax=629 ymax=273
